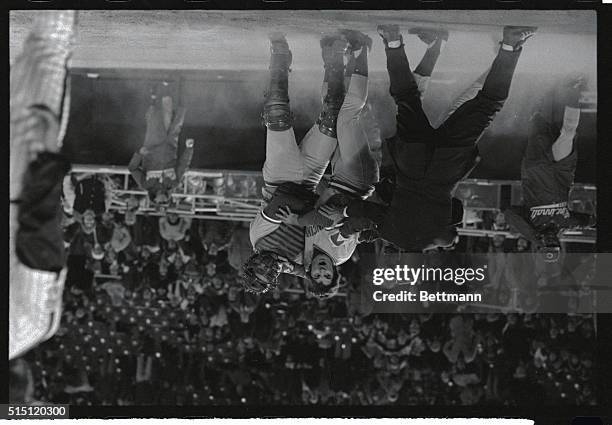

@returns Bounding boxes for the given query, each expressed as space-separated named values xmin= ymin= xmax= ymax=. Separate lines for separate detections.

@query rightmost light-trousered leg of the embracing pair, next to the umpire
xmin=330 ymin=30 xmax=379 ymax=196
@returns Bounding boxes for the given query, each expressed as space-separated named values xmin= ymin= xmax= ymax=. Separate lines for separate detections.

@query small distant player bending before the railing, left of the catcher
xmin=128 ymin=84 xmax=194 ymax=206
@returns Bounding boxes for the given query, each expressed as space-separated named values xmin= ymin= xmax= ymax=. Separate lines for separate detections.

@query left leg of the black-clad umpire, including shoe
xmin=378 ymin=25 xmax=433 ymax=144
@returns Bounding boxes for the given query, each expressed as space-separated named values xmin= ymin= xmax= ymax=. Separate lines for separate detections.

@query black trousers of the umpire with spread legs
xmin=386 ymin=47 xmax=520 ymax=149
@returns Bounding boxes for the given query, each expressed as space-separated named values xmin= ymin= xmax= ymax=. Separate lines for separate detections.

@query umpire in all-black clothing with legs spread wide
xmin=346 ymin=25 xmax=536 ymax=252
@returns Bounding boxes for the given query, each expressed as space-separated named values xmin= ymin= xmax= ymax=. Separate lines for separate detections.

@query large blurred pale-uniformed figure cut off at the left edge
xmin=9 ymin=11 xmax=77 ymax=359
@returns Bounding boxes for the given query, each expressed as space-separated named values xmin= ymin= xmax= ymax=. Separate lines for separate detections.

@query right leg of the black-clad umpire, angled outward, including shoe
xmin=437 ymin=27 xmax=536 ymax=147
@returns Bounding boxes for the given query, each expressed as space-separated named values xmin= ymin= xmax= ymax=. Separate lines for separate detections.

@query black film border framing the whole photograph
xmin=0 ymin=0 xmax=612 ymax=425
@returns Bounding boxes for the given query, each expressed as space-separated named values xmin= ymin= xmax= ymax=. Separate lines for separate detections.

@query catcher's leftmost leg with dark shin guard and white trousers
xmin=262 ymin=33 xmax=304 ymax=185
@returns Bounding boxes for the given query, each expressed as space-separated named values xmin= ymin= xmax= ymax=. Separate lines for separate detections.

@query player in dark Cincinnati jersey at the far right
xmin=504 ymin=78 xmax=595 ymax=262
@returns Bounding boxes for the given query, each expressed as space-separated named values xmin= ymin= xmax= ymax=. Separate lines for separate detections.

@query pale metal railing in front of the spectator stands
xmin=71 ymin=164 xmax=597 ymax=244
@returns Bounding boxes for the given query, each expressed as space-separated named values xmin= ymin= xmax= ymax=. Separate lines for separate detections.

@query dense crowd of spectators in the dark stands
xmin=9 ymin=176 xmax=597 ymax=405
